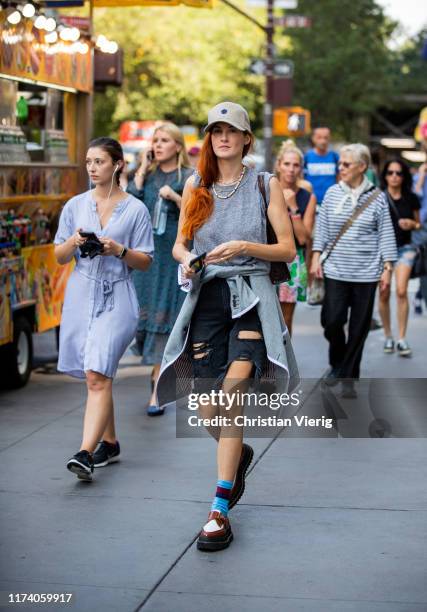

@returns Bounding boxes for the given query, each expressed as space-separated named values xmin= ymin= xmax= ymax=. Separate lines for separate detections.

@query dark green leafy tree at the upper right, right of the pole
xmin=288 ymin=0 xmax=396 ymax=139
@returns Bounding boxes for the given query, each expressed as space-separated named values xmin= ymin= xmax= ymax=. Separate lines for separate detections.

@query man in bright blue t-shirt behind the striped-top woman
xmin=304 ymin=127 xmax=338 ymax=205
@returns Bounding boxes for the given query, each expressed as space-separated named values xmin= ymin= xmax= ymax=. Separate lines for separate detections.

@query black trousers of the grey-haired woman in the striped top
xmin=321 ymin=278 xmax=377 ymax=378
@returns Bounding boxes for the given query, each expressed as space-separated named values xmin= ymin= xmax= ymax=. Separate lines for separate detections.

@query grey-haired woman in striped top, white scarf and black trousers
xmin=310 ymin=144 xmax=397 ymax=397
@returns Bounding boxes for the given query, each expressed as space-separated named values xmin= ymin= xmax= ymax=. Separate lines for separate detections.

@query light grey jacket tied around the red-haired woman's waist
xmin=157 ymin=261 xmax=300 ymax=407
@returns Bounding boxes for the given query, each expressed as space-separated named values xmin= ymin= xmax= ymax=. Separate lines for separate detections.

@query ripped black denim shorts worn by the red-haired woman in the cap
xmin=190 ymin=278 xmax=267 ymax=392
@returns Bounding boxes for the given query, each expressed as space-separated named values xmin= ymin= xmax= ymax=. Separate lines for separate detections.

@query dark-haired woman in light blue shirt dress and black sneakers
xmin=55 ymin=138 xmax=154 ymax=480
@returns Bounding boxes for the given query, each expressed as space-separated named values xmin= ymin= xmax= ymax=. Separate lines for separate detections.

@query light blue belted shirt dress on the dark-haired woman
xmin=54 ymin=191 xmax=154 ymax=378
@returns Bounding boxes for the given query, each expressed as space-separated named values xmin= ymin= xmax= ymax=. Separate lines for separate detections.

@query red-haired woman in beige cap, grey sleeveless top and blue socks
xmin=158 ymin=102 xmax=298 ymax=550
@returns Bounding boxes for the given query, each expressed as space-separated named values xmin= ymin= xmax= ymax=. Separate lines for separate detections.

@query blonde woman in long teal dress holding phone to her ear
xmin=127 ymin=123 xmax=193 ymax=416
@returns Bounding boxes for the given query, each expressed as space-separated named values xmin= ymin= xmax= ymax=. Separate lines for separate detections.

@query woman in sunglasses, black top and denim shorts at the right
xmin=379 ymin=159 xmax=421 ymax=357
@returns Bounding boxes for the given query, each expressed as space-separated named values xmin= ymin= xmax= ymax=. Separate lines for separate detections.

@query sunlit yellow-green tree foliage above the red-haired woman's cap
xmin=95 ymin=4 xmax=270 ymax=134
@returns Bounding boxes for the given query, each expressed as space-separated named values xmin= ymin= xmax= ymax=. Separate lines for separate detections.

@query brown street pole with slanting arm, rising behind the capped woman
xmin=222 ymin=0 xmax=274 ymax=171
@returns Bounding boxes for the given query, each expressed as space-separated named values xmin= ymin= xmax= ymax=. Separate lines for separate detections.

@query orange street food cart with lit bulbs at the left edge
xmin=0 ymin=11 xmax=93 ymax=387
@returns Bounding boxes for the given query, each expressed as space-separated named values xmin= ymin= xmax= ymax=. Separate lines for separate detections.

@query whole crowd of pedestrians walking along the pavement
xmin=55 ymin=102 xmax=427 ymax=550
